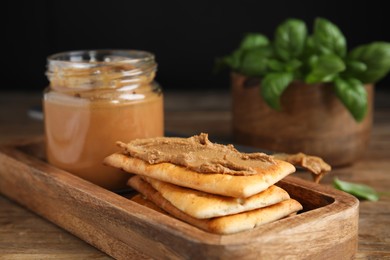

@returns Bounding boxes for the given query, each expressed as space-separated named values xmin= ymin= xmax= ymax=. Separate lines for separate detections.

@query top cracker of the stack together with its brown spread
xmin=104 ymin=134 xmax=295 ymax=198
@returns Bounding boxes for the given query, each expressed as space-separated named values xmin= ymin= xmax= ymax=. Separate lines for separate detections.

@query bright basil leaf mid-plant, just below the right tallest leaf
xmin=305 ymin=54 xmax=345 ymax=84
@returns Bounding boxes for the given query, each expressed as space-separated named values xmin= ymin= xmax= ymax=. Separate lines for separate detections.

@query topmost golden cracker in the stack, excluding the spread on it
xmin=104 ymin=153 xmax=295 ymax=198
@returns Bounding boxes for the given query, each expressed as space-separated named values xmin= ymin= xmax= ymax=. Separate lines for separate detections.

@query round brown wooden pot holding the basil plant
xmin=231 ymin=73 xmax=374 ymax=166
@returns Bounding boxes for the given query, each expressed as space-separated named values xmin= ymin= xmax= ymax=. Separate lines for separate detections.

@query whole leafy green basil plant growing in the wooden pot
xmin=215 ymin=18 xmax=390 ymax=122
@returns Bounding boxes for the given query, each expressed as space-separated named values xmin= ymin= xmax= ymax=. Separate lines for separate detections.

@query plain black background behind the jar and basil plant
xmin=4 ymin=0 xmax=390 ymax=91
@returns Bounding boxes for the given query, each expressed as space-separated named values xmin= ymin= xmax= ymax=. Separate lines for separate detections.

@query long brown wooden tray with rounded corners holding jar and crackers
xmin=0 ymin=140 xmax=359 ymax=259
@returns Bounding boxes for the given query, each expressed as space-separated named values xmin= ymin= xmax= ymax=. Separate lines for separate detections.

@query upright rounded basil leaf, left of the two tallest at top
xmin=274 ymin=19 xmax=307 ymax=61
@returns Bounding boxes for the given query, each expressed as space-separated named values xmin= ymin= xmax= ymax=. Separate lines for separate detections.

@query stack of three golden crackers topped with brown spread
xmin=104 ymin=134 xmax=302 ymax=234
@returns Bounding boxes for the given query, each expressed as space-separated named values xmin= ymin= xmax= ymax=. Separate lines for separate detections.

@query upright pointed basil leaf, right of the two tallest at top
xmin=313 ymin=18 xmax=347 ymax=57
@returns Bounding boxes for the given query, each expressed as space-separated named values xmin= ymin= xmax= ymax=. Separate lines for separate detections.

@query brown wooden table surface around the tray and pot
xmin=0 ymin=91 xmax=390 ymax=259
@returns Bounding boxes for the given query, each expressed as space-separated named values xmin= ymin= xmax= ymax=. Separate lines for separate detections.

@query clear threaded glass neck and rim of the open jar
xmin=46 ymin=50 xmax=157 ymax=92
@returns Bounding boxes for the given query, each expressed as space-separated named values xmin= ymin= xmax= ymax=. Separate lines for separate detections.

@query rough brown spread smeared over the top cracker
xmin=117 ymin=133 xmax=276 ymax=175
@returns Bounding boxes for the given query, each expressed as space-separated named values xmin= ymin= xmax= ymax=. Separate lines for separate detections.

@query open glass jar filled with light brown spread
xmin=43 ymin=50 xmax=164 ymax=190
